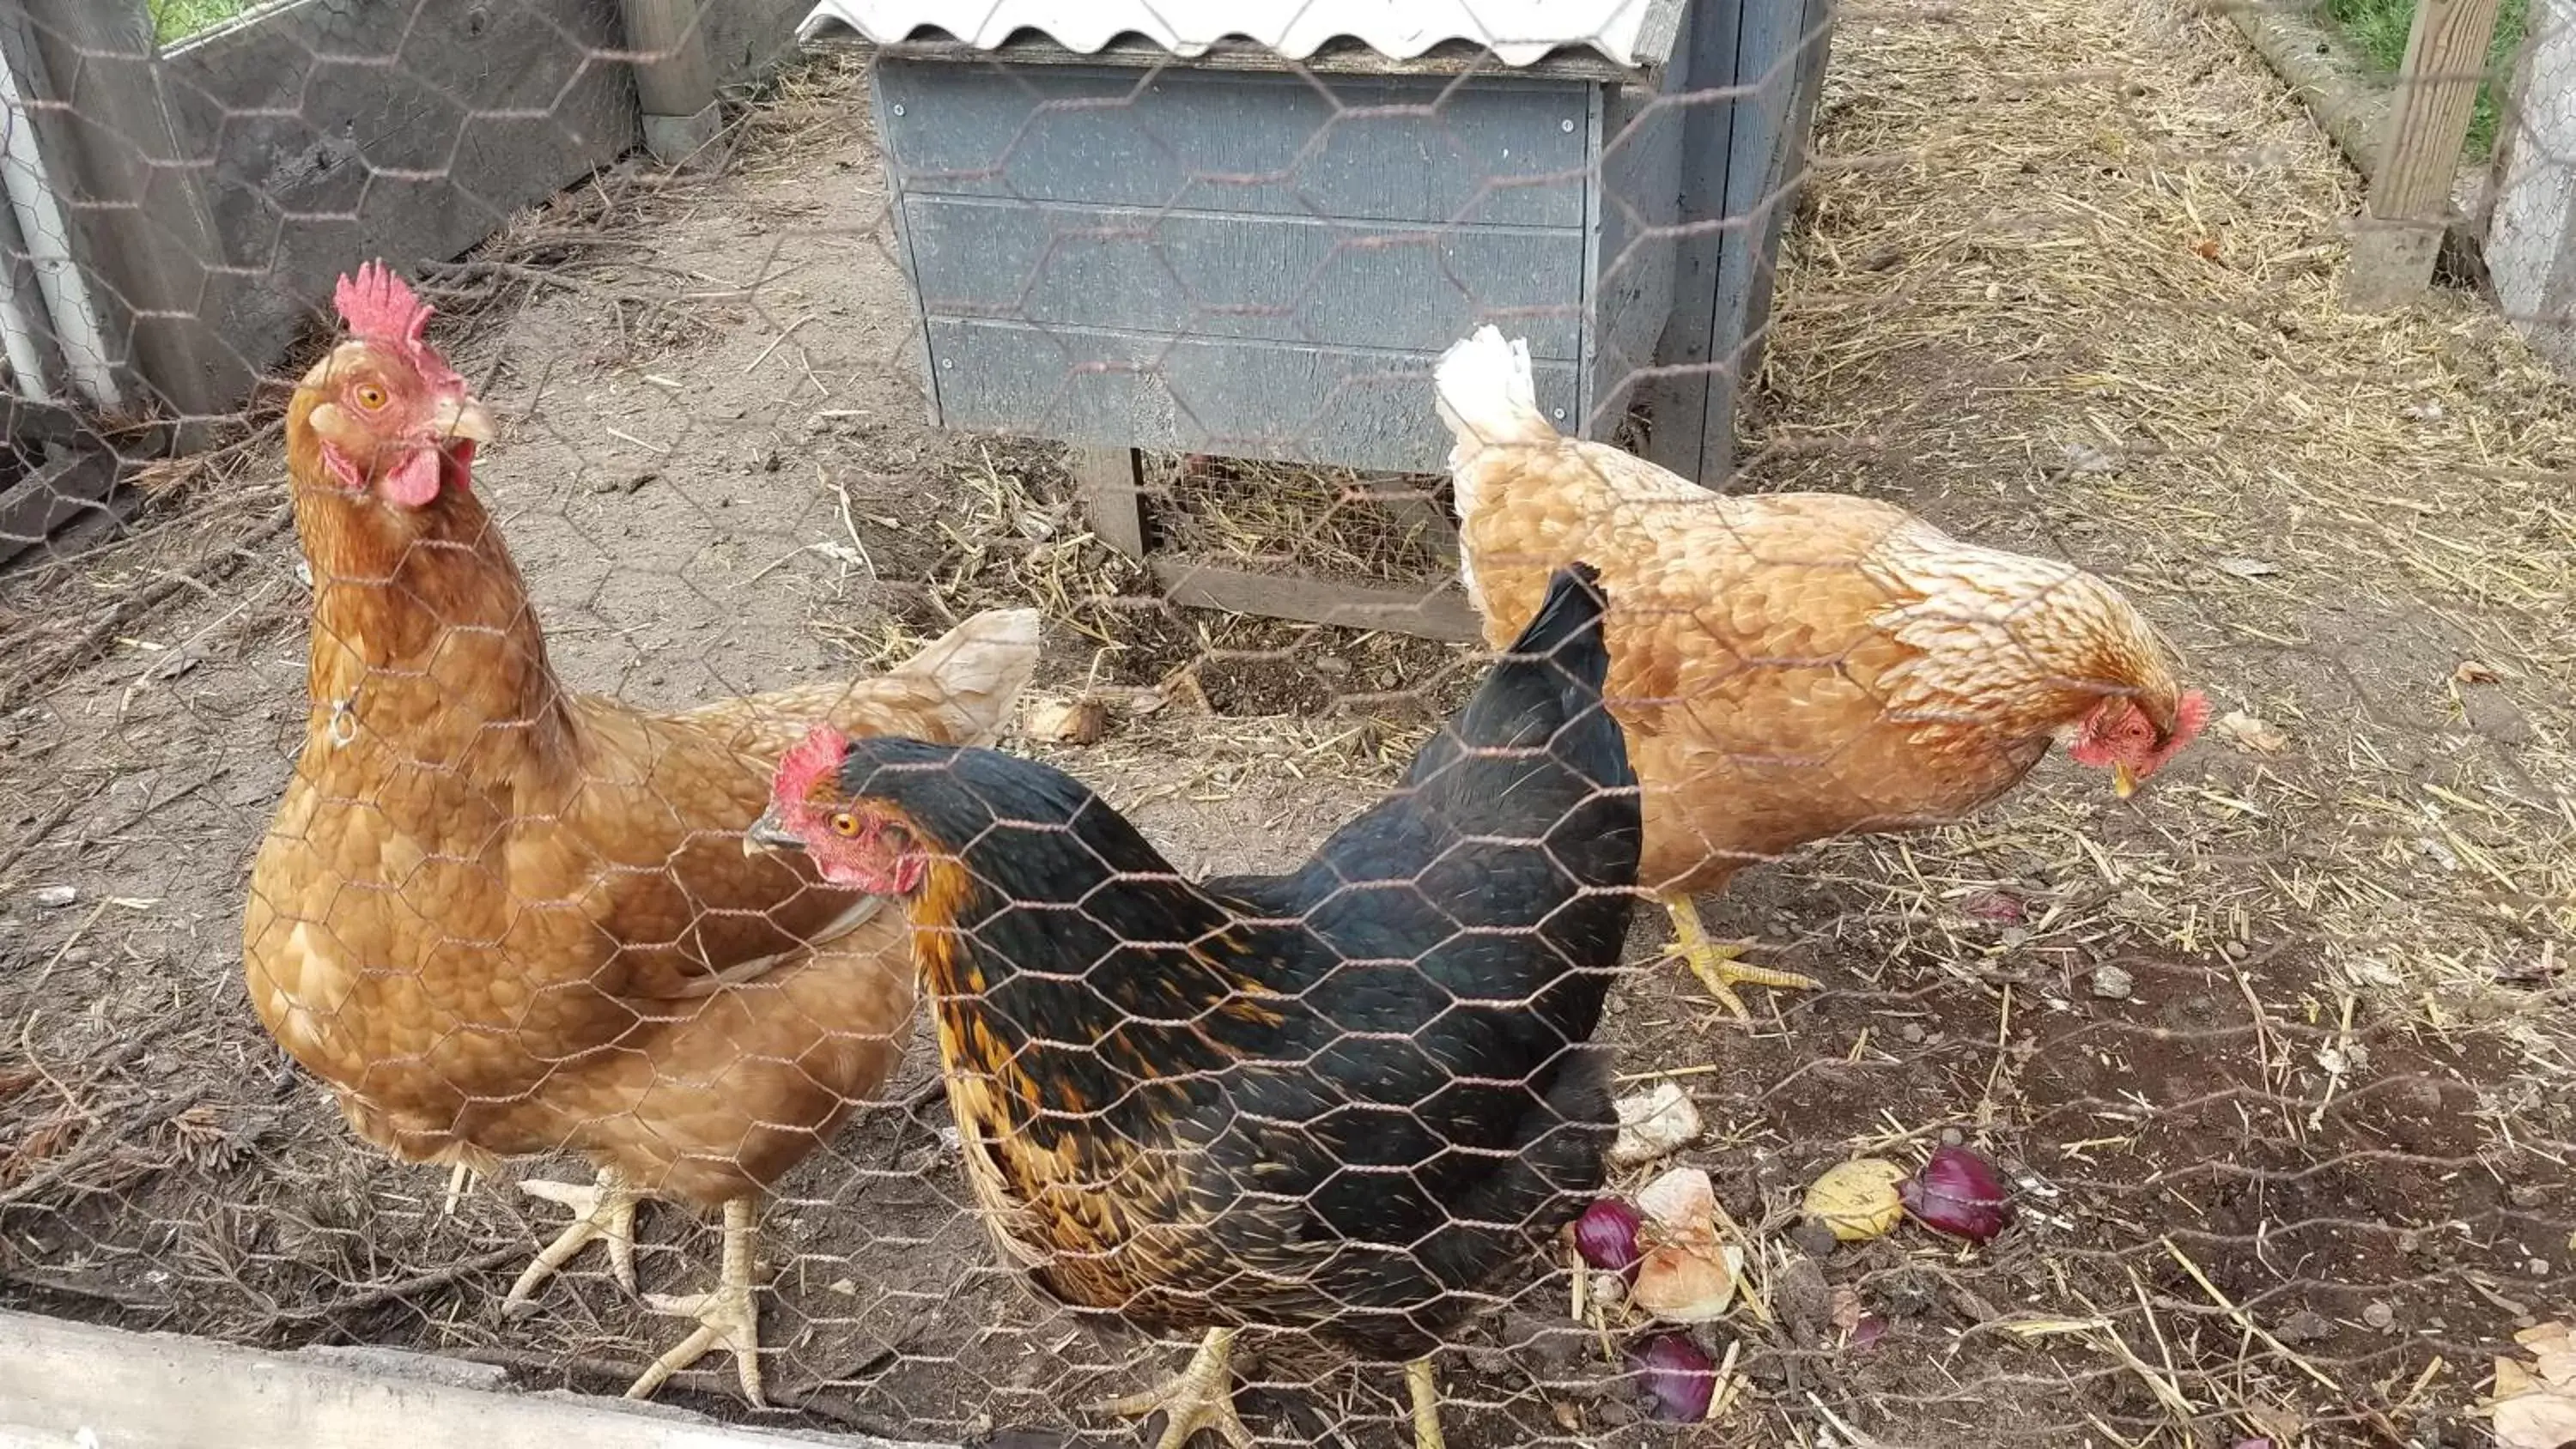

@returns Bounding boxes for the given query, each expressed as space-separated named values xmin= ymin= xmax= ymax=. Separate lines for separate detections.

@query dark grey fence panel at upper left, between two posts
xmin=165 ymin=0 xmax=639 ymax=391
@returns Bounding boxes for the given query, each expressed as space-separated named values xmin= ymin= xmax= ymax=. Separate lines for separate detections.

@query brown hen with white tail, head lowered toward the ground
xmin=1435 ymin=327 xmax=2208 ymax=1016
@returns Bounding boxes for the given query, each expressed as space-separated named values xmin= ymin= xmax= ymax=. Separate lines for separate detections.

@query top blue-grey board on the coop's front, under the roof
xmin=878 ymin=57 xmax=1587 ymax=227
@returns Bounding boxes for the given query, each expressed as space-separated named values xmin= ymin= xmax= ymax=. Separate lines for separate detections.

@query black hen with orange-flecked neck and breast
xmin=752 ymin=567 xmax=1641 ymax=1449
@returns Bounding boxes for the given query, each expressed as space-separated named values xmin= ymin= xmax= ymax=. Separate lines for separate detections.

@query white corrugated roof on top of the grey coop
xmin=796 ymin=0 xmax=1682 ymax=67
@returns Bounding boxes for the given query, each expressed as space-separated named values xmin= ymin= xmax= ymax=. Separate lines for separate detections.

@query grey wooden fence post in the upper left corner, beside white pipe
xmin=0 ymin=0 xmax=243 ymax=434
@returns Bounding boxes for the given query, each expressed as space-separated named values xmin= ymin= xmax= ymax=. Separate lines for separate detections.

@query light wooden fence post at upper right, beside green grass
xmin=2344 ymin=0 xmax=2496 ymax=312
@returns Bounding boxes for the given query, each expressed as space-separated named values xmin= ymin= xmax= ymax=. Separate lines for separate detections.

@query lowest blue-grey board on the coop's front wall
xmin=930 ymin=317 xmax=1574 ymax=474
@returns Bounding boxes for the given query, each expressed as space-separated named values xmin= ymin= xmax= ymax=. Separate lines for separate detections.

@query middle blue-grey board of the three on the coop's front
xmin=904 ymin=196 xmax=1584 ymax=361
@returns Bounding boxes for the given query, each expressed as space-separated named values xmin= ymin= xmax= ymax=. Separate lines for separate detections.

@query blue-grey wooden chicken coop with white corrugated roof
xmin=801 ymin=0 xmax=1826 ymax=639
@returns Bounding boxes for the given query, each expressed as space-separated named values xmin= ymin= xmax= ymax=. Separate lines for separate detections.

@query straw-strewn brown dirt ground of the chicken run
xmin=0 ymin=0 xmax=2576 ymax=1449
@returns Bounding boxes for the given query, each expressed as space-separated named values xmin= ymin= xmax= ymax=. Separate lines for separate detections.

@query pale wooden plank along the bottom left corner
xmin=0 ymin=1313 xmax=927 ymax=1449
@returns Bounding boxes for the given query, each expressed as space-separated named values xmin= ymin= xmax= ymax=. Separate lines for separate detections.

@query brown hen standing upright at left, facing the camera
xmin=242 ymin=268 xmax=1038 ymax=1403
